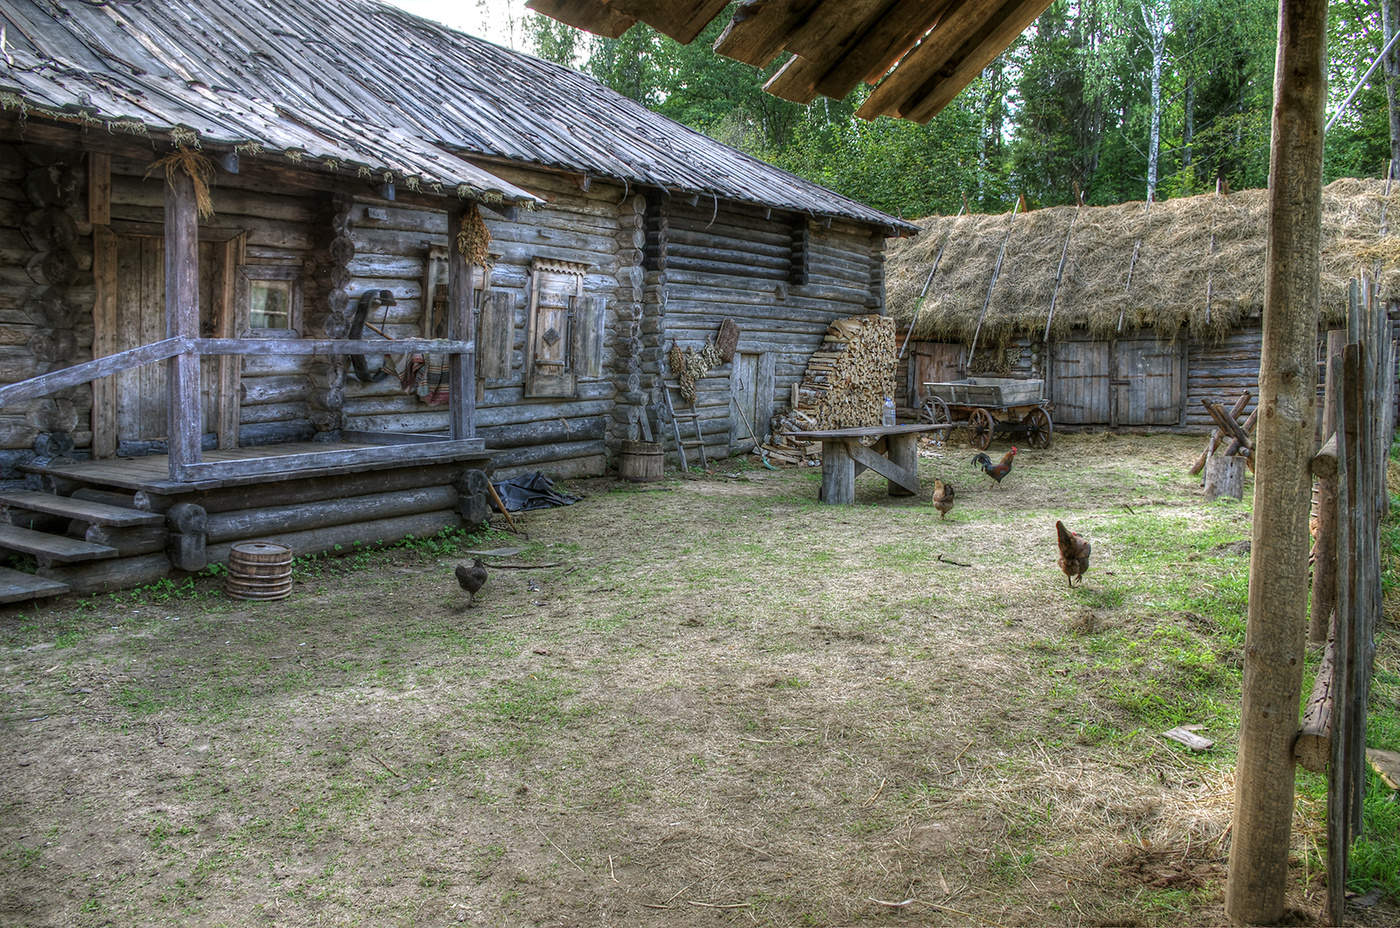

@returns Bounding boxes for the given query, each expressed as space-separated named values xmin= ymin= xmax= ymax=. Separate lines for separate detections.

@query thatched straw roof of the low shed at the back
xmin=886 ymin=179 xmax=1400 ymax=344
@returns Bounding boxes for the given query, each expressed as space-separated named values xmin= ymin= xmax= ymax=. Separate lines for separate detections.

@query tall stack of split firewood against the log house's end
xmin=764 ymin=315 xmax=897 ymax=463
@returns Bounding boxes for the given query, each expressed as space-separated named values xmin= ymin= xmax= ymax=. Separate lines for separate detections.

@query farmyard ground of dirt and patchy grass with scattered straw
xmin=0 ymin=435 xmax=1380 ymax=925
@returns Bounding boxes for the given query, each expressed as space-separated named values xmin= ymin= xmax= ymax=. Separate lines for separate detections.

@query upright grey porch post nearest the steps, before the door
xmin=165 ymin=169 xmax=202 ymax=480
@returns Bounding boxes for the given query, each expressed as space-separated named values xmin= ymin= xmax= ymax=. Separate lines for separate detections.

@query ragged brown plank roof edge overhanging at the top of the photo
xmin=525 ymin=0 xmax=1050 ymax=123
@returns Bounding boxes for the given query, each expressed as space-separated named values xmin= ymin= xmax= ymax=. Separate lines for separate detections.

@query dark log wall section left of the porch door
xmin=0 ymin=143 xmax=92 ymax=480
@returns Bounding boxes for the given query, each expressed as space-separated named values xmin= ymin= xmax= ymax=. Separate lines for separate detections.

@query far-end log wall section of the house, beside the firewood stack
xmin=662 ymin=199 xmax=883 ymax=458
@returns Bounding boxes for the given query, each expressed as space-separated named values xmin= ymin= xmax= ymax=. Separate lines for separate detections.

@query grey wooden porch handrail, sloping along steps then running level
xmin=0 ymin=337 xmax=476 ymax=409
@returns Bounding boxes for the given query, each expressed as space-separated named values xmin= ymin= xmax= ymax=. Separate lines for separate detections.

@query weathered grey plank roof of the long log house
xmin=0 ymin=0 xmax=914 ymax=232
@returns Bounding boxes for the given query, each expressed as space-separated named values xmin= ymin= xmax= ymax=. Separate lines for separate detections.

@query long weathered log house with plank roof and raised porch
xmin=0 ymin=0 xmax=914 ymax=600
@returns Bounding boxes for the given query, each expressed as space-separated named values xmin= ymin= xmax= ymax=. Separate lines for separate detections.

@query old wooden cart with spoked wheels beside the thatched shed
xmin=920 ymin=377 xmax=1054 ymax=451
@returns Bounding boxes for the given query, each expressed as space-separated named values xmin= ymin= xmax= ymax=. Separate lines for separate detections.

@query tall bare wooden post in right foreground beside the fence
xmin=1225 ymin=0 xmax=1327 ymax=924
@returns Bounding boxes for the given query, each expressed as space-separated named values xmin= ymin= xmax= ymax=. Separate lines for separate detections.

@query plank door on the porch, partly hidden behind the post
xmin=113 ymin=235 xmax=224 ymax=454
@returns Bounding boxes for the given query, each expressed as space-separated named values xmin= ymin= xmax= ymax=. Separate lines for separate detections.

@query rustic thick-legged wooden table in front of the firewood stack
xmin=791 ymin=423 xmax=952 ymax=505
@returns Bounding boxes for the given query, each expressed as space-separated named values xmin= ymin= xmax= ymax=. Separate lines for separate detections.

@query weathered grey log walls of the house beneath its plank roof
xmin=0 ymin=127 xmax=883 ymax=477
